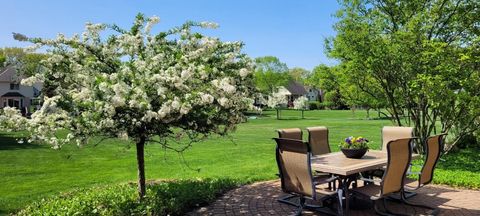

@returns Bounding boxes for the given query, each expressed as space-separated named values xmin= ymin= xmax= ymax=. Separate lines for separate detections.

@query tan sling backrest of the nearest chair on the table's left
xmin=274 ymin=138 xmax=316 ymax=199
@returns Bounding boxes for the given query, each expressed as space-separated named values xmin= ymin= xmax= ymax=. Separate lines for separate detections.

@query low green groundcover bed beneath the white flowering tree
xmin=17 ymin=179 xmax=238 ymax=215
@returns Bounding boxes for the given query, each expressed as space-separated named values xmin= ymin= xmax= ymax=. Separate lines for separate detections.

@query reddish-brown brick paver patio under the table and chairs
xmin=189 ymin=181 xmax=480 ymax=216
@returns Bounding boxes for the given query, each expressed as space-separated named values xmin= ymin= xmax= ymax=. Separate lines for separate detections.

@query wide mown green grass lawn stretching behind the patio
xmin=0 ymin=111 xmax=480 ymax=214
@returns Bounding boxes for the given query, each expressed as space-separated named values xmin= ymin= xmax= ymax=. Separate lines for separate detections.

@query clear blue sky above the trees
xmin=0 ymin=0 xmax=339 ymax=70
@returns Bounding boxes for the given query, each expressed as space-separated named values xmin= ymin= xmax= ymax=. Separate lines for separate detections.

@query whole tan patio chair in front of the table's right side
xmin=352 ymin=138 xmax=413 ymax=215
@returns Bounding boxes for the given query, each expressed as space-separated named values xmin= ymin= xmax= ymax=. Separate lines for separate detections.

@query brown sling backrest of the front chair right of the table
xmin=381 ymin=138 xmax=413 ymax=196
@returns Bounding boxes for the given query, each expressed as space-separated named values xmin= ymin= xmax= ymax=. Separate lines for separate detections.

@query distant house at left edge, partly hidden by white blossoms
xmin=0 ymin=67 xmax=41 ymax=112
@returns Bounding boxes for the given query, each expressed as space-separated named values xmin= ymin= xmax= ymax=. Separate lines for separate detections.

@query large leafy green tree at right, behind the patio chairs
xmin=326 ymin=0 xmax=480 ymax=152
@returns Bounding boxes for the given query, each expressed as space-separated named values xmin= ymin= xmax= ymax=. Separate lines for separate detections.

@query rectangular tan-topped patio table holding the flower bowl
xmin=311 ymin=150 xmax=420 ymax=215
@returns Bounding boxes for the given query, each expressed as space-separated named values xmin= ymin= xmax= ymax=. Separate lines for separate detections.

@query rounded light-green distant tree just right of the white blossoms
xmin=255 ymin=56 xmax=291 ymax=94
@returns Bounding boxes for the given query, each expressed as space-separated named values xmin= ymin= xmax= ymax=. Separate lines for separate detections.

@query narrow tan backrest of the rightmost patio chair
xmin=419 ymin=134 xmax=446 ymax=186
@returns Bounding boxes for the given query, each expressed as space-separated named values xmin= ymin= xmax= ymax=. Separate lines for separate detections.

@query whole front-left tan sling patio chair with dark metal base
xmin=273 ymin=138 xmax=342 ymax=215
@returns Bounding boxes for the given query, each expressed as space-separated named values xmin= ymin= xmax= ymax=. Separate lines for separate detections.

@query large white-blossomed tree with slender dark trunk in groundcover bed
xmin=2 ymin=14 xmax=254 ymax=198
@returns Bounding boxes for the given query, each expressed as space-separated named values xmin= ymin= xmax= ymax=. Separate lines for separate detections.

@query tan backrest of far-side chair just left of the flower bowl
xmin=307 ymin=127 xmax=331 ymax=155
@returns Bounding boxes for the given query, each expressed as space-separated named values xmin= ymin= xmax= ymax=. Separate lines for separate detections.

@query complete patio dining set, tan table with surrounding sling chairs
xmin=274 ymin=126 xmax=445 ymax=215
